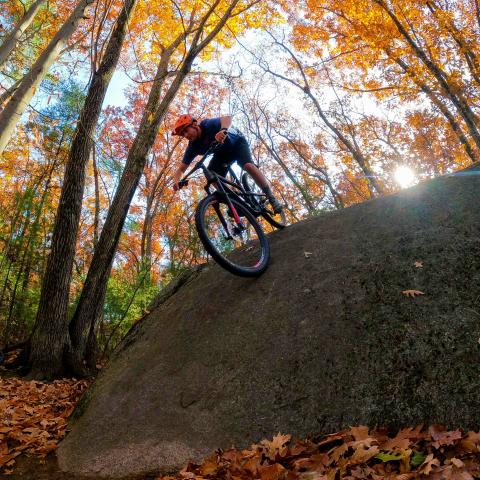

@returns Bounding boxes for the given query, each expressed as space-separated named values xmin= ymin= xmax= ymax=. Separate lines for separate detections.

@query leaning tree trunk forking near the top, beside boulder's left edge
xmin=70 ymin=0 xmax=239 ymax=374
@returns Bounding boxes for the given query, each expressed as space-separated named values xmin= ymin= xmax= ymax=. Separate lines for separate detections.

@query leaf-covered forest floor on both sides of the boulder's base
xmin=0 ymin=348 xmax=480 ymax=480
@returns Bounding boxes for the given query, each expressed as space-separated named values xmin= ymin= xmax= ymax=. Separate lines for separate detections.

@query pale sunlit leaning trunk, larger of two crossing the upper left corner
xmin=0 ymin=0 xmax=94 ymax=155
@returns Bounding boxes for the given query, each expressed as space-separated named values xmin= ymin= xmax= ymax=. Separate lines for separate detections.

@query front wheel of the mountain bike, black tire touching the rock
xmin=195 ymin=194 xmax=270 ymax=277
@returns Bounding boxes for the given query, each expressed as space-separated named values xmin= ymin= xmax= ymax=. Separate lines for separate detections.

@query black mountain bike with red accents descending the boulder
xmin=178 ymin=142 xmax=286 ymax=277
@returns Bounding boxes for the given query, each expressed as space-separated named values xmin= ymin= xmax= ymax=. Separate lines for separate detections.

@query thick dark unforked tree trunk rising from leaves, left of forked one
xmin=30 ymin=0 xmax=136 ymax=378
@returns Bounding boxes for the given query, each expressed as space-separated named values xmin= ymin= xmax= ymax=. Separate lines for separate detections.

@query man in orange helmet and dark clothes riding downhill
xmin=172 ymin=114 xmax=283 ymax=214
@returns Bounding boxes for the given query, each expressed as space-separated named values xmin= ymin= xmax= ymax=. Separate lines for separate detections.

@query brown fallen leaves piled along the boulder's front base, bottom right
xmin=170 ymin=425 xmax=480 ymax=480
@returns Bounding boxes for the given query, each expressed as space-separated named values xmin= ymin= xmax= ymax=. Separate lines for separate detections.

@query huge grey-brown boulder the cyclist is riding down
xmin=58 ymin=166 xmax=480 ymax=477
